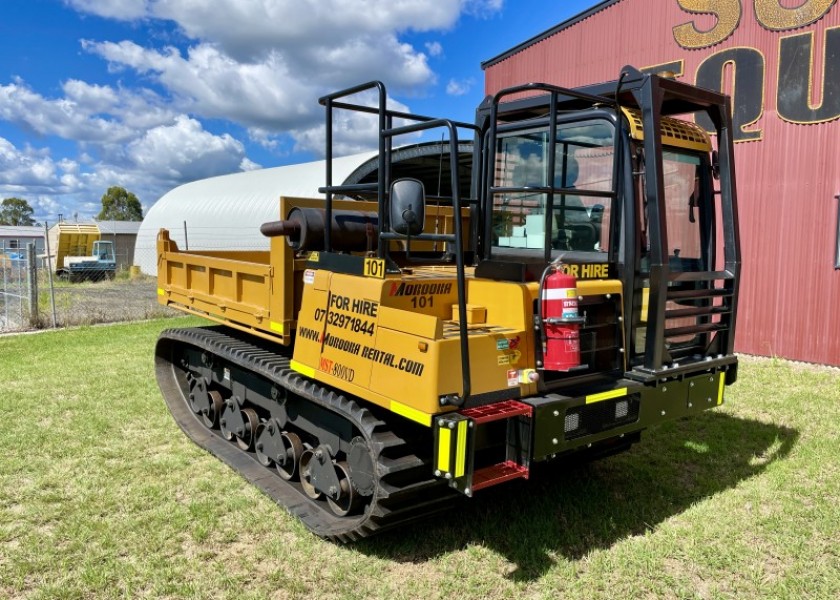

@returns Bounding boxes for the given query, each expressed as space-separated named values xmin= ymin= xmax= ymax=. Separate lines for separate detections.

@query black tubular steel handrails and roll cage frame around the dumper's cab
xmin=319 ymin=66 xmax=741 ymax=406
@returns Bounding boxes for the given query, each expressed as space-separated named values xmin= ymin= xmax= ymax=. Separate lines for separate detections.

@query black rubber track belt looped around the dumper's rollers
xmin=155 ymin=327 xmax=461 ymax=543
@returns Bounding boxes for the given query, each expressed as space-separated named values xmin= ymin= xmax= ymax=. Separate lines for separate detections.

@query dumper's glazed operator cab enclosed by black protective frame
xmin=475 ymin=67 xmax=740 ymax=381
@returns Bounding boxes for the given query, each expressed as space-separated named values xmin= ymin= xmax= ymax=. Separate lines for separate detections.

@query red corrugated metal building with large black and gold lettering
xmin=483 ymin=0 xmax=840 ymax=366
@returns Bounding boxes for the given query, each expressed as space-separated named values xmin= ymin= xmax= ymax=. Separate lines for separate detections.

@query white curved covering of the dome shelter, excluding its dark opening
xmin=134 ymin=152 xmax=376 ymax=275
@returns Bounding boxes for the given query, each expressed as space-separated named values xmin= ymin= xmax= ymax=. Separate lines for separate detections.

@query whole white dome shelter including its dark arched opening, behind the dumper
xmin=134 ymin=142 xmax=472 ymax=275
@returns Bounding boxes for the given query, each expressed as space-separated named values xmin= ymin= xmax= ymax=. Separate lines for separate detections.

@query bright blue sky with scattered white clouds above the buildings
xmin=0 ymin=0 xmax=598 ymax=223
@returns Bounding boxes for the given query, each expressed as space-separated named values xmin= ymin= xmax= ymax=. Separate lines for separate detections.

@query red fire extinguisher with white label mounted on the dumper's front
xmin=540 ymin=265 xmax=583 ymax=371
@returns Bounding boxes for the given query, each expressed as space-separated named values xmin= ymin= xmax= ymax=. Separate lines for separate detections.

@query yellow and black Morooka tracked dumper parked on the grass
xmin=156 ymin=67 xmax=740 ymax=541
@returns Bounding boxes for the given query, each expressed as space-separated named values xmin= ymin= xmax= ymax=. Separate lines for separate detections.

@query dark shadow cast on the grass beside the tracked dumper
xmin=357 ymin=412 xmax=799 ymax=580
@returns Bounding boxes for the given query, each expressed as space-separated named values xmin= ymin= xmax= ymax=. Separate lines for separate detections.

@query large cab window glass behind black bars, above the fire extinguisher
xmin=493 ymin=120 xmax=614 ymax=252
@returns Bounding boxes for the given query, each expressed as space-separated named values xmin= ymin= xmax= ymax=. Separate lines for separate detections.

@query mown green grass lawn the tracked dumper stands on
xmin=0 ymin=319 xmax=840 ymax=600
